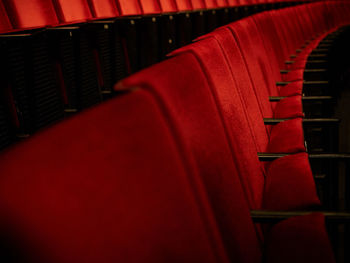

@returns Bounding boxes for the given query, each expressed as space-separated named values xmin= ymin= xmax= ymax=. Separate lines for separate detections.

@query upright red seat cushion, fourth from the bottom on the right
xmin=275 ymin=95 xmax=304 ymax=119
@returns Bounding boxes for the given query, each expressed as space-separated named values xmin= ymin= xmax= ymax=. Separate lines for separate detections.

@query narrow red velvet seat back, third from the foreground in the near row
xmin=171 ymin=38 xmax=268 ymax=207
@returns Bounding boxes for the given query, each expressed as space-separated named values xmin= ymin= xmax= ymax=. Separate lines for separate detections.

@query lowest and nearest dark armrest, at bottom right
xmin=250 ymin=210 xmax=350 ymax=224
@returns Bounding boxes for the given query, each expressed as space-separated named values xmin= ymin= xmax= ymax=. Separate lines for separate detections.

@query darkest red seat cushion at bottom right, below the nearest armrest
xmin=265 ymin=213 xmax=335 ymax=263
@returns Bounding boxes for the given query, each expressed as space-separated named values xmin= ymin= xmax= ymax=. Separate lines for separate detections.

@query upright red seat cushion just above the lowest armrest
xmin=263 ymin=153 xmax=320 ymax=211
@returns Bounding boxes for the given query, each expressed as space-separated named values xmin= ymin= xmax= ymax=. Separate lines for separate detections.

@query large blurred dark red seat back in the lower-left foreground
xmin=0 ymin=90 xmax=227 ymax=263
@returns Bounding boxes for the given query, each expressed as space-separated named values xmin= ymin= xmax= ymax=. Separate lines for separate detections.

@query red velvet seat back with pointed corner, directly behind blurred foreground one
xmin=116 ymin=53 xmax=260 ymax=262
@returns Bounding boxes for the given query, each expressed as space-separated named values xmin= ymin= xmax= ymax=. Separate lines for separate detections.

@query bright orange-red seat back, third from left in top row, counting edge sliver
xmin=52 ymin=0 xmax=93 ymax=23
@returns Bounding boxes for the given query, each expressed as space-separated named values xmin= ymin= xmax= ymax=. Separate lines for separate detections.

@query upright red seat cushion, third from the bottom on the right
xmin=267 ymin=118 xmax=305 ymax=153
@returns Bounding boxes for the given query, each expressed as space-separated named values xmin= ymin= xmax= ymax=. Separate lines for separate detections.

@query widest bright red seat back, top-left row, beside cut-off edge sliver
xmin=3 ymin=0 xmax=59 ymax=29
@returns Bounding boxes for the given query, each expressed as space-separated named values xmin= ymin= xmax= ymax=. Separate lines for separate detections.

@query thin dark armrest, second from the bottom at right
xmin=258 ymin=153 xmax=350 ymax=162
